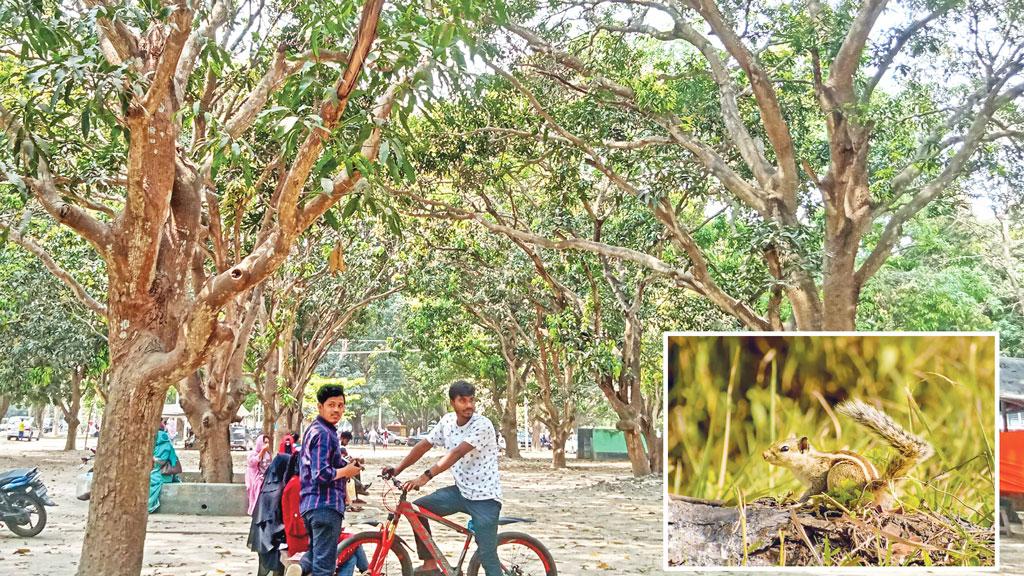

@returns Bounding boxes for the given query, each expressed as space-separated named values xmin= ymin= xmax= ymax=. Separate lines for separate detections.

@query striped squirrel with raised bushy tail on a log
xmin=762 ymin=400 xmax=934 ymax=505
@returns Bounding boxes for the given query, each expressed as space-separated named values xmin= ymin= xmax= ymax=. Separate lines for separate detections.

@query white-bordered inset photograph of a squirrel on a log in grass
xmin=666 ymin=333 xmax=997 ymax=570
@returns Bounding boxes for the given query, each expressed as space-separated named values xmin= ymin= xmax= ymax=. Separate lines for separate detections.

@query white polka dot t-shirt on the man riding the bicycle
xmin=427 ymin=412 xmax=502 ymax=501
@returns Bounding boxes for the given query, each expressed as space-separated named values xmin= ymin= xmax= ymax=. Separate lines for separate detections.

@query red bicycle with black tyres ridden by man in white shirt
xmin=338 ymin=477 xmax=558 ymax=576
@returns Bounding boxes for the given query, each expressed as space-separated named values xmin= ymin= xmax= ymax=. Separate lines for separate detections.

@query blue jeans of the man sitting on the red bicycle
xmin=414 ymin=486 xmax=502 ymax=576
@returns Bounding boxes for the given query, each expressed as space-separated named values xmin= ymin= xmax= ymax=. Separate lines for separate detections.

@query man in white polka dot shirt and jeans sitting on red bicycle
xmin=382 ymin=380 xmax=502 ymax=576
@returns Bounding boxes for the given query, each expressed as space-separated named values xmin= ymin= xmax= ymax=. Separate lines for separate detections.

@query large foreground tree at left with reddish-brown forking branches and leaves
xmin=0 ymin=0 xmax=463 ymax=575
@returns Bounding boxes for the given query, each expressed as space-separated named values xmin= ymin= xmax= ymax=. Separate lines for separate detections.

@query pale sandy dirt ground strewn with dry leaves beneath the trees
xmin=0 ymin=439 xmax=1024 ymax=576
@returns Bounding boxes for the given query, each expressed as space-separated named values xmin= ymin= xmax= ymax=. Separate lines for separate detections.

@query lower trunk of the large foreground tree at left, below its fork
xmin=78 ymin=362 xmax=167 ymax=576
